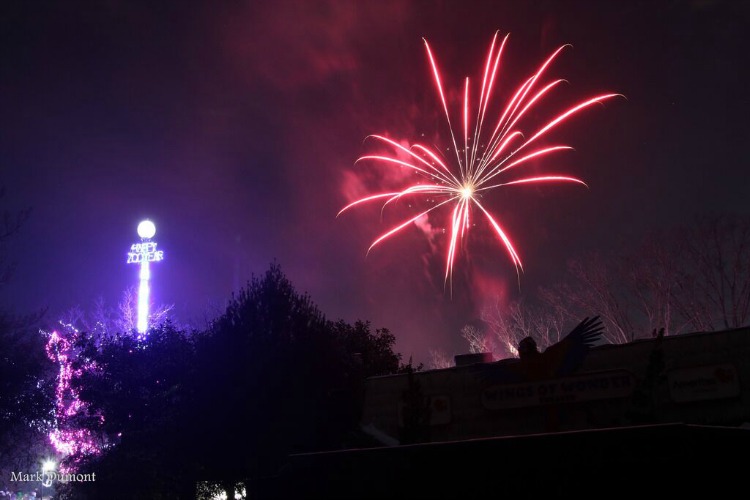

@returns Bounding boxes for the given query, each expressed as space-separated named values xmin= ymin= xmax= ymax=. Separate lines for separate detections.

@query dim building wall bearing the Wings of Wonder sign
xmin=362 ymin=328 xmax=750 ymax=443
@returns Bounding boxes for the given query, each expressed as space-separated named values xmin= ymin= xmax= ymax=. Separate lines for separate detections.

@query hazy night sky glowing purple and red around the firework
xmin=0 ymin=0 xmax=750 ymax=360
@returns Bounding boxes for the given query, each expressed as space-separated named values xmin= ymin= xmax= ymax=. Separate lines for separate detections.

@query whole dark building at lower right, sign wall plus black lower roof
xmin=251 ymin=328 xmax=750 ymax=499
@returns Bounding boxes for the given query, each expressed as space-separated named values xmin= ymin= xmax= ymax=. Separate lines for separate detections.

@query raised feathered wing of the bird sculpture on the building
xmin=542 ymin=316 xmax=604 ymax=377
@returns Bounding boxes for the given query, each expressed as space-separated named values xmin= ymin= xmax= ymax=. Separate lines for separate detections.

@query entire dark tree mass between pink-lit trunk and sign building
xmin=62 ymin=264 xmax=403 ymax=499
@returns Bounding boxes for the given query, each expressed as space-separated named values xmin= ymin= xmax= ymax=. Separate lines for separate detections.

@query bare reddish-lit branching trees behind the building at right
xmin=478 ymin=214 xmax=750 ymax=348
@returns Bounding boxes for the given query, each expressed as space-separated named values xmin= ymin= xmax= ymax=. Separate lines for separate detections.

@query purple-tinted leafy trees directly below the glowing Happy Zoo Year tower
xmin=61 ymin=322 xmax=195 ymax=499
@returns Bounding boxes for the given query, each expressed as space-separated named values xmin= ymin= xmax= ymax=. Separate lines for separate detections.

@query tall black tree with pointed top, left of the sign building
xmin=196 ymin=263 xmax=400 ymax=495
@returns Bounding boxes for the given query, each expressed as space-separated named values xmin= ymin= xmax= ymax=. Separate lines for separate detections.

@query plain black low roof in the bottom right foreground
xmin=258 ymin=424 xmax=750 ymax=500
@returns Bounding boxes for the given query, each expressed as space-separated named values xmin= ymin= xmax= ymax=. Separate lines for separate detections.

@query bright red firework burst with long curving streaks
xmin=338 ymin=32 xmax=620 ymax=283
